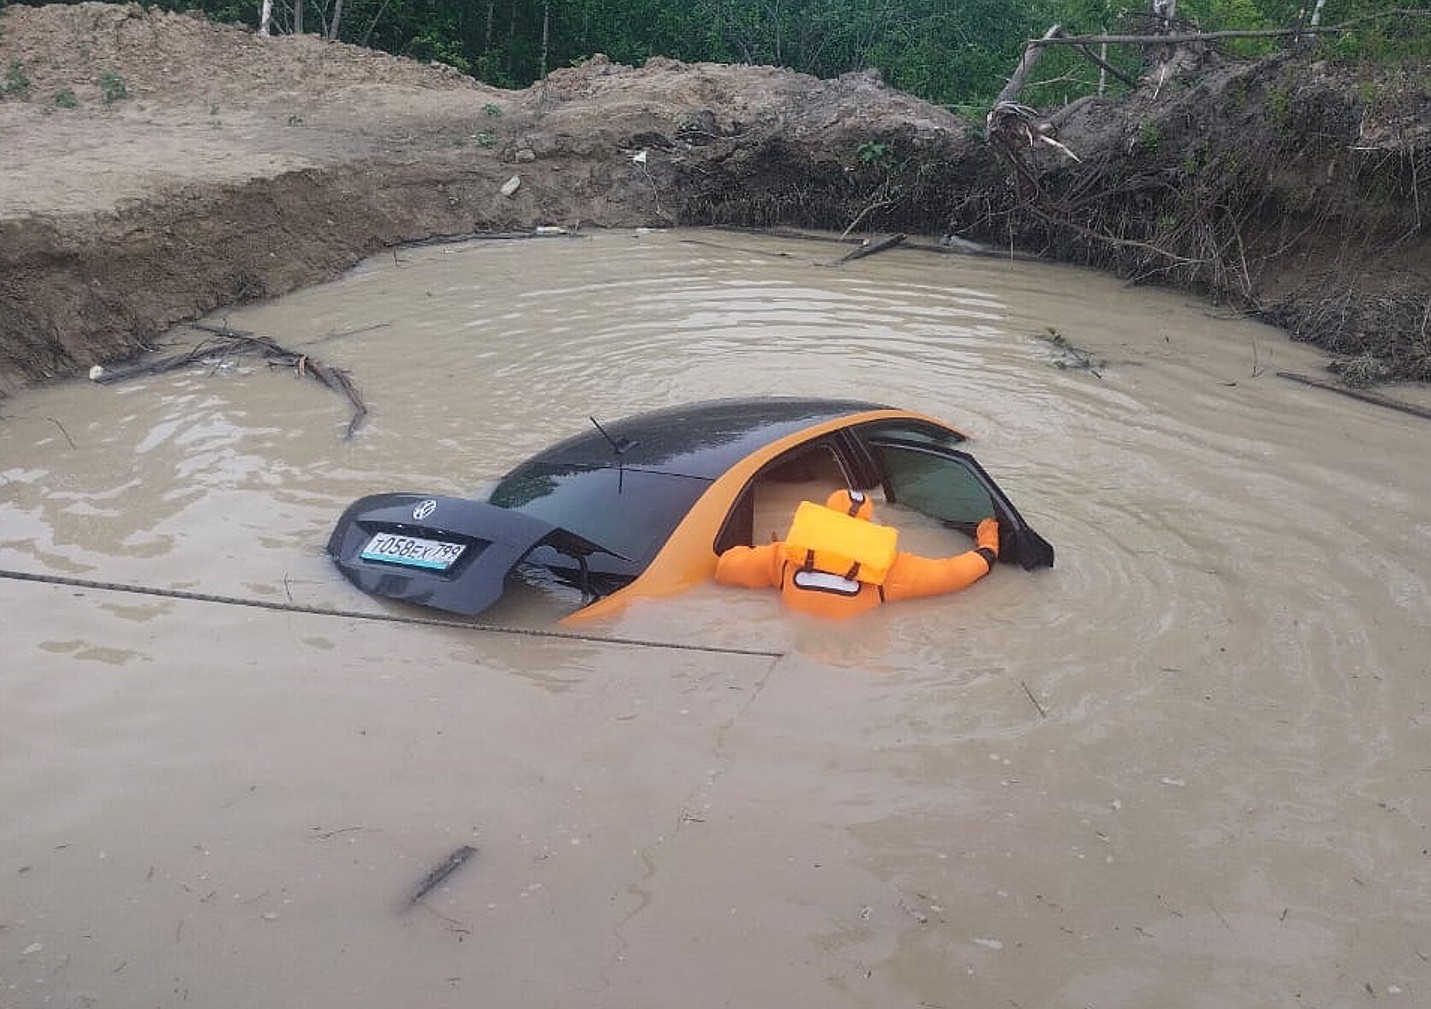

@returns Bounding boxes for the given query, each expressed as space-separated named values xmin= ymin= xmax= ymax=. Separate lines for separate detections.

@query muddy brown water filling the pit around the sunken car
xmin=0 ymin=232 xmax=1431 ymax=1009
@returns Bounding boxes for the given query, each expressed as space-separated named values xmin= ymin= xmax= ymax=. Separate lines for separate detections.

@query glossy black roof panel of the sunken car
xmin=514 ymin=396 xmax=887 ymax=479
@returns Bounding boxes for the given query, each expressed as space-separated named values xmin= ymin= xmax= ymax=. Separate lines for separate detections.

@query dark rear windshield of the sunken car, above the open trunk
xmin=489 ymin=462 xmax=711 ymax=574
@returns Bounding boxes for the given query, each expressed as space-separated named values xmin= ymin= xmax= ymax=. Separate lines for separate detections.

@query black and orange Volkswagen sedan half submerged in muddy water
xmin=328 ymin=398 xmax=1053 ymax=620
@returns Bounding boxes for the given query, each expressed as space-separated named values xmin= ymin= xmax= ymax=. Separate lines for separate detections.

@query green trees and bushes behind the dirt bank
xmin=41 ymin=0 xmax=1431 ymax=107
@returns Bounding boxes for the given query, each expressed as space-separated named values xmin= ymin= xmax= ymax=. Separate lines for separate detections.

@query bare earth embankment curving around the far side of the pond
xmin=0 ymin=3 xmax=1431 ymax=394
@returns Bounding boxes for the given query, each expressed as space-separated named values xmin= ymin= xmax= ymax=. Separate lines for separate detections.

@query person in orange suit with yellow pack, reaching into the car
xmin=716 ymin=491 xmax=999 ymax=617
